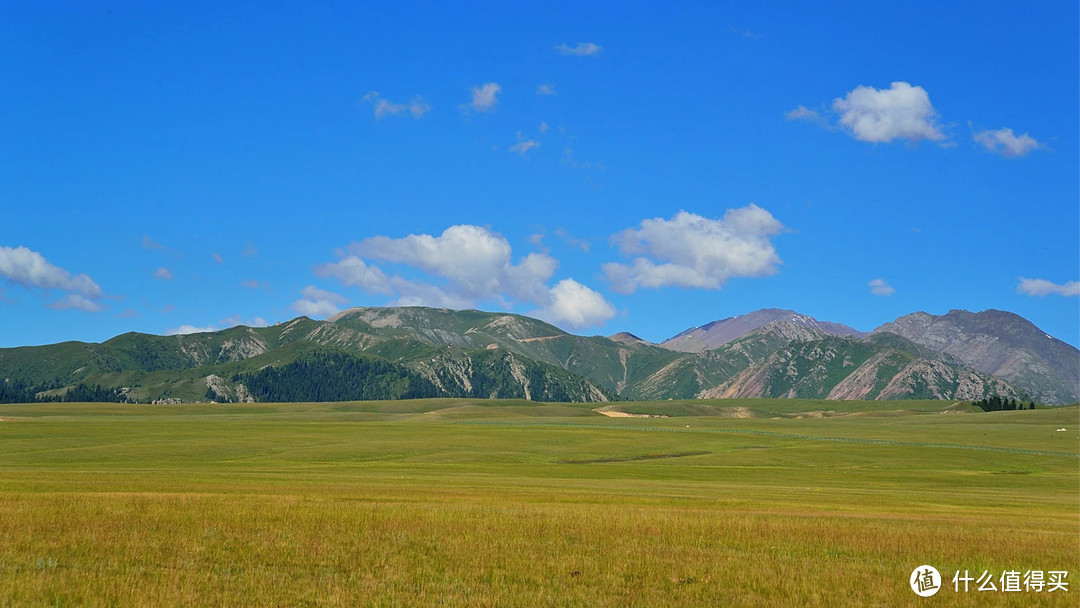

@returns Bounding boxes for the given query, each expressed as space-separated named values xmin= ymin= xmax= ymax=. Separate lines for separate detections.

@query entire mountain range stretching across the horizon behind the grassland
xmin=0 ymin=307 xmax=1080 ymax=404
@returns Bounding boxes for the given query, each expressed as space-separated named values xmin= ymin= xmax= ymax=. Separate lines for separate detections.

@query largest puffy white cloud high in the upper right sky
xmin=829 ymin=82 xmax=945 ymax=144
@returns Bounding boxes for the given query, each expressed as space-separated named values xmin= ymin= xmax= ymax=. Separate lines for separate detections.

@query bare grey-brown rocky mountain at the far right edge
xmin=874 ymin=310 xmax=1080 ymax=404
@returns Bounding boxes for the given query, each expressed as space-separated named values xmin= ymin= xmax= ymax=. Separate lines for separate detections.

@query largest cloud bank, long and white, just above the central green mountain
xmin=315 ymin=225 xmax=613 ymax=327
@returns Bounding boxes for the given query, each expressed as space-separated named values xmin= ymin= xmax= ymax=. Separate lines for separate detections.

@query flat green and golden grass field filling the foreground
xmin=0 ymin=400 xmax=1080 ymax=607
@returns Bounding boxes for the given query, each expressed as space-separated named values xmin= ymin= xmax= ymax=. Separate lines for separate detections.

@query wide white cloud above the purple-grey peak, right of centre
xmin=604 ymin=204 xmax=784 ymax=294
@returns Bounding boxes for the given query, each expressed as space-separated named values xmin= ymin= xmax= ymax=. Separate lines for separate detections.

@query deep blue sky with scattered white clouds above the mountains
xmin=0 ymin=2 xmax=1080 ymax=347
